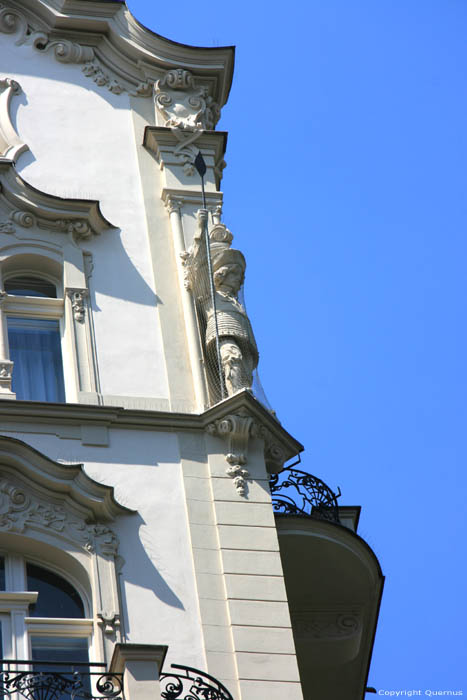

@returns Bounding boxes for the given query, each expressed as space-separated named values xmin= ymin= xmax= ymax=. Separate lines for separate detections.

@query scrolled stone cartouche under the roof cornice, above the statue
xmin=155 ymin=68 xmax=220 ymax=130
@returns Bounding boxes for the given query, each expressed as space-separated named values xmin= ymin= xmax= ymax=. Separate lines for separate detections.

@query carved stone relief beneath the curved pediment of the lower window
xmin=0 ymin=479 xmax=118 ymax=557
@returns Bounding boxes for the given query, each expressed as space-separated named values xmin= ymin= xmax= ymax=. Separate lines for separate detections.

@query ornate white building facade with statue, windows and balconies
xmin=0 ymin=0 xmax=382 ymax=700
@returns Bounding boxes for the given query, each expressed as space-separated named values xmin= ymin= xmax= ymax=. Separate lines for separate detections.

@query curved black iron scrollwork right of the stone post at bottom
xmin=159 ymin=664 xmax=233 ymax=700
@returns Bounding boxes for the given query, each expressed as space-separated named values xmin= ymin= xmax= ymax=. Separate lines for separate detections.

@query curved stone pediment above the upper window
xmin=0 ymin=158 xmax=113 ymax=240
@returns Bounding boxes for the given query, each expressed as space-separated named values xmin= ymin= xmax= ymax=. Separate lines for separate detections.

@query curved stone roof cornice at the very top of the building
xmin=0 ymin=0 xmax=234 ymax=106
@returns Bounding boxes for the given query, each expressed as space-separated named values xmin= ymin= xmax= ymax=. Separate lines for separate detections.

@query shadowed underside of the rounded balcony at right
xmin=276 ymin=508 xmax=384 ymax=700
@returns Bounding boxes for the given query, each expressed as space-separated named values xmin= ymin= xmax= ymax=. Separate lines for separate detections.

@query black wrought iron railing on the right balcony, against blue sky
xmin=269 ymin=467 xmax=341 ymax=523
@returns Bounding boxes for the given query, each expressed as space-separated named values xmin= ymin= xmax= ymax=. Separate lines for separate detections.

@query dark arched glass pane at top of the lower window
xmin=26 ymin=564 xmax=84 ymax=617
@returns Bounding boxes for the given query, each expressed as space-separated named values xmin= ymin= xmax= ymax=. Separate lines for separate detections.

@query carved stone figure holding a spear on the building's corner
xmin=185 ymin=209 xmax=259 ymax=396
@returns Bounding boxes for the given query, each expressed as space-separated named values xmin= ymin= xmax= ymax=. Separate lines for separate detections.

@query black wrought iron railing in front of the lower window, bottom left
xmin=0 ymin=659 xmax=124 ymax=700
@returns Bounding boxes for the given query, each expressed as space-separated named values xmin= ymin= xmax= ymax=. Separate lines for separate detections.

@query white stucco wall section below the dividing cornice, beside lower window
xmin=2 ymin=426 xmax=206 ymax=668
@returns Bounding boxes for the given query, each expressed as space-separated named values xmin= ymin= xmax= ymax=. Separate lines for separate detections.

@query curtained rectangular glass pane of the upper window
xmin=8 ymin=316 xmax=65 ymax=403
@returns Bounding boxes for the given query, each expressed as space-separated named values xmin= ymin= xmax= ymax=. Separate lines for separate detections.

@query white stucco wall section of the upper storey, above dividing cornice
xmin=0 ymin=34 xmax=168 ymax=398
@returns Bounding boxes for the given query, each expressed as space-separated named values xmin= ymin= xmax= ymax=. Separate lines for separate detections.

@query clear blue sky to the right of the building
xmin=128 ymin=0 xmax=467 ymax=697
